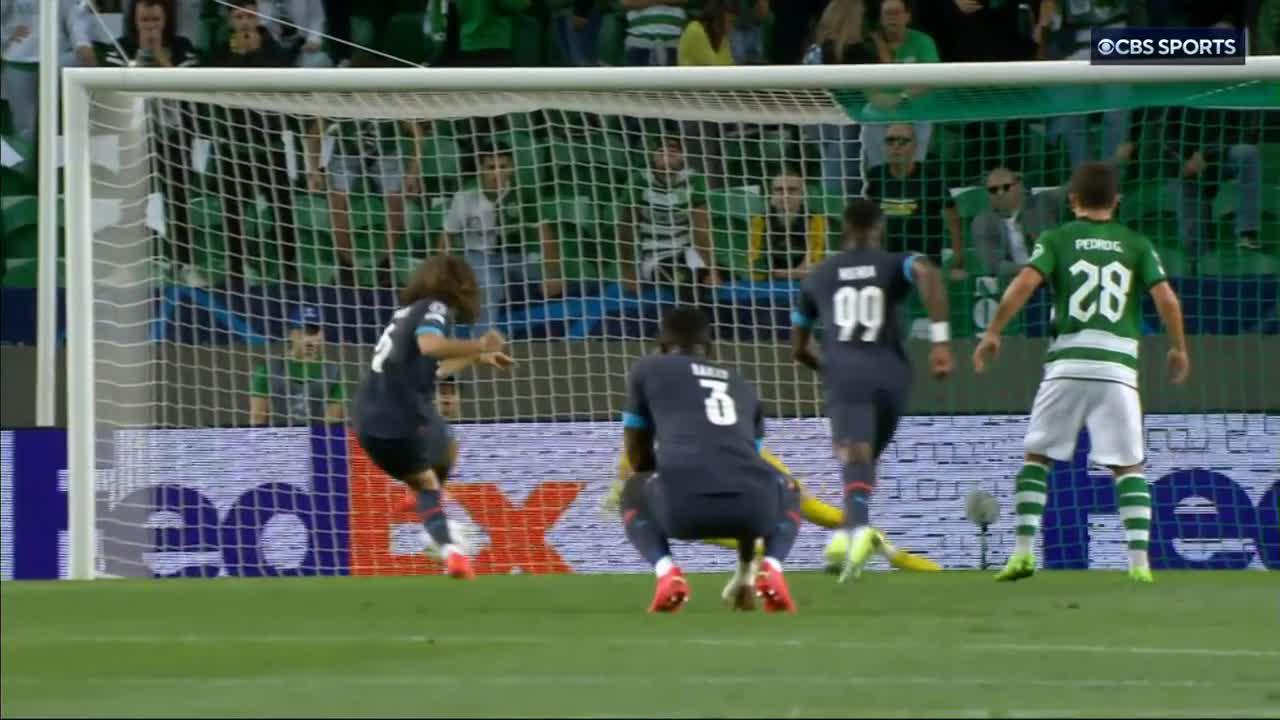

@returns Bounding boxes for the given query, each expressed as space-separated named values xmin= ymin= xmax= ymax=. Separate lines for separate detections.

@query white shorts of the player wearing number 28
xmin=1024 ymin=378 xmax=1147 ymax=468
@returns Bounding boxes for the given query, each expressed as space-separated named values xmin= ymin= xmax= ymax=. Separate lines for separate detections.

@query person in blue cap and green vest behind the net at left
xmin=248 ymin=305 xmax=347 ymax=425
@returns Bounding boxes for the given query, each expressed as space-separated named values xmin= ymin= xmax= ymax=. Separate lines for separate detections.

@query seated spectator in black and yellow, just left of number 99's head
xmin=748 ymin=168 xmax=827 ymax=281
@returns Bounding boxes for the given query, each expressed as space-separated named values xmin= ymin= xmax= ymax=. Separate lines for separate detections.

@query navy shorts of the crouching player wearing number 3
xmin=632 ymin=473 xmax=800 ymax=539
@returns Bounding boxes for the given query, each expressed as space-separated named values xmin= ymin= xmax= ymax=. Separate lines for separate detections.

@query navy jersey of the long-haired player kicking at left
xmin=352 ymin=300 xmax=449 ymax=438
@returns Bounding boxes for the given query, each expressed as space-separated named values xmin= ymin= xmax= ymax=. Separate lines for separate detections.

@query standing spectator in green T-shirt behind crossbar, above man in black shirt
xmin=863 ymin=0 xmax=938 ymax=168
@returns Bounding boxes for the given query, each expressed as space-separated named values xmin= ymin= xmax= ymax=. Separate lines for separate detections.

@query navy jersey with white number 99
xmin=791 ymin=249 xmax=915 ymax=393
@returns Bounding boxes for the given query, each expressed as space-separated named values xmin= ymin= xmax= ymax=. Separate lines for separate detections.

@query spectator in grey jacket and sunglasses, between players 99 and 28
xmin=970 ymin=168 xmax=1064 ymax=279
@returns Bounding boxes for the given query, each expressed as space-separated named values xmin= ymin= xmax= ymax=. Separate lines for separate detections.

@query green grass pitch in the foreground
xmin=0 ymin=571 xmax=1280 ymax=717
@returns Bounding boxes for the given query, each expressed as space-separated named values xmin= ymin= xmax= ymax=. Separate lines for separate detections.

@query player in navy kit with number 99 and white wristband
xmin=791 ymin=199 xmax=952 ymax=582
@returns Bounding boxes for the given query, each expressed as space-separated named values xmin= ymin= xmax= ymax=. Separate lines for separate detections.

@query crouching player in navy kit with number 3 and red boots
xmin=621 ymin=307 xmax=800 ymax=612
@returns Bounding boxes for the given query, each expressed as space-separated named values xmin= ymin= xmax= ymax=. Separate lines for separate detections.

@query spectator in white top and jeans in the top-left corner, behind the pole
xmin=0 ymin=0 xmax=96 ymax=143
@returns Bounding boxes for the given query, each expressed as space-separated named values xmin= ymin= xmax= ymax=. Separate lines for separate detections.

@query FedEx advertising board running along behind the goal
xmin=0 ymin=414 xmax=1280 ymax=579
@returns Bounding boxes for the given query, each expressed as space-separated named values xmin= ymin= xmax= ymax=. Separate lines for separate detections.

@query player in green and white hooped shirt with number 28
xmin=973 ymin=163 xmax=1190 ymax=583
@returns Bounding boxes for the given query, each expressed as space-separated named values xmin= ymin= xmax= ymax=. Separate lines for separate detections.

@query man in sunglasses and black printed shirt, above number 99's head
xmin=867 ymin=123 xmax=964 ymax=272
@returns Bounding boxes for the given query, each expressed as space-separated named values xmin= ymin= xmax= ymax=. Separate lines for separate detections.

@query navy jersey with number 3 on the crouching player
xmin=622 ymin=354 xmax=776 ymax=492
